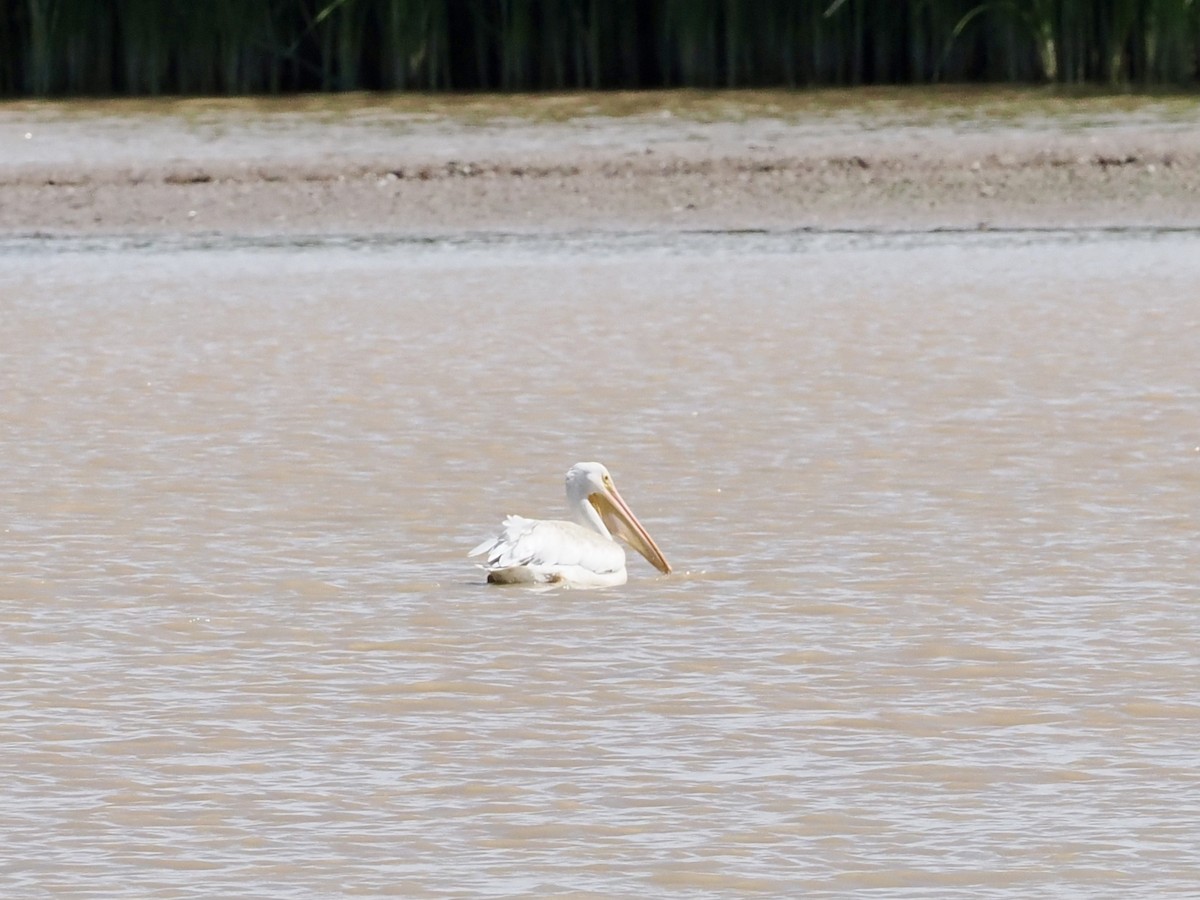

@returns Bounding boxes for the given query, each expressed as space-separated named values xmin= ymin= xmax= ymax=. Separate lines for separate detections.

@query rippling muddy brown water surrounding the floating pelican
xmin=0 ymin=232 xmax=1200 ymax=898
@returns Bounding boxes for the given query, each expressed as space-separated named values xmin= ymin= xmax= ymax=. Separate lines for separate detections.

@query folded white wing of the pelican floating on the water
xmin=468 ymin=516 xmax=625 ymax=574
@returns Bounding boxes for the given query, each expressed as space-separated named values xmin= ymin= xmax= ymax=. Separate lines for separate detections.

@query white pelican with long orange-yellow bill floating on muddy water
xmin=467 ymin=462 xmax=671 ymax=588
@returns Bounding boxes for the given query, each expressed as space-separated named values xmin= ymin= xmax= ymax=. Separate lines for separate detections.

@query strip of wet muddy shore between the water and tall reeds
xmin=0 ymin=91 xmax=1200 ymax=234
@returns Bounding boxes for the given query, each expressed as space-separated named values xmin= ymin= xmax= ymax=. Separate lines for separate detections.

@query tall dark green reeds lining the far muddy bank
xmin=0 ymin=0 xmax=1200 ymax=96
